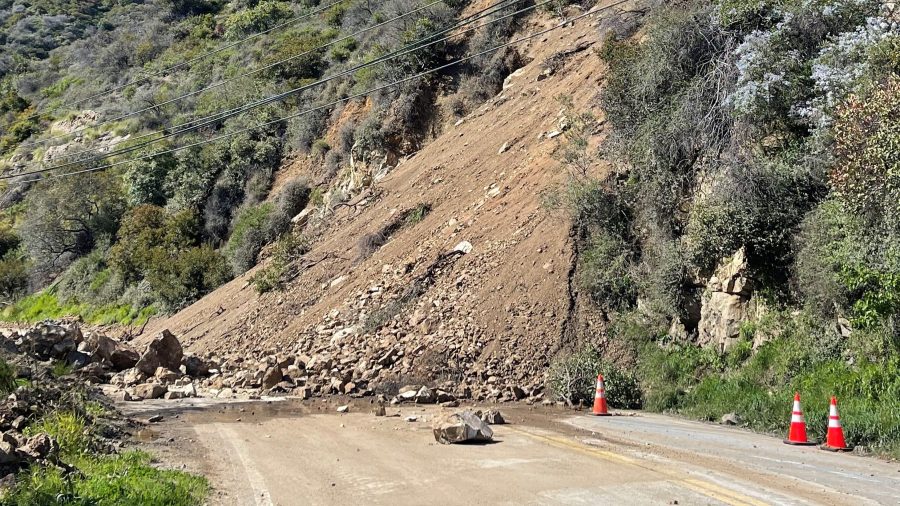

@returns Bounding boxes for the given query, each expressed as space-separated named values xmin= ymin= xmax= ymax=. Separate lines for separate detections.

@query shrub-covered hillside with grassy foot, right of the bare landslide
xmin=554 ymin=0 xmax=900 ymax=454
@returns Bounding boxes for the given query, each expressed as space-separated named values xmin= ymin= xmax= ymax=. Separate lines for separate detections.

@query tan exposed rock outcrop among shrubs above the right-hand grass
xmin=697 ymin=248 xmax=753 ymax=351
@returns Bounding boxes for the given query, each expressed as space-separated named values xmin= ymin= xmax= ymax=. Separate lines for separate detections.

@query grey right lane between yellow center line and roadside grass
xmin=566 ymin=413 xmax=900 ymax=505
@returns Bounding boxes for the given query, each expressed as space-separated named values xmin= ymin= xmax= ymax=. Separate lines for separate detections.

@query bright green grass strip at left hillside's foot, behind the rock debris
xmin=0 ymin=290 xmax=157 ymax=325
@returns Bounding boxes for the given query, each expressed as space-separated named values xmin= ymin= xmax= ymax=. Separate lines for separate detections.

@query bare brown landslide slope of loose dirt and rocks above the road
xmin=139 ymin=11 xmax=614 ymax=399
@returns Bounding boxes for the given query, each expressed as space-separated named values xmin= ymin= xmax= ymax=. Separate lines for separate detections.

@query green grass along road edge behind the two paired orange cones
xmin=640 ymin=338 xmax=900 ymax=457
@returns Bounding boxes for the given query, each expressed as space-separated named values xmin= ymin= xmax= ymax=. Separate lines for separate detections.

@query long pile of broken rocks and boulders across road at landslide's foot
xmin=2 ymin=321 xmax=552 ymax=407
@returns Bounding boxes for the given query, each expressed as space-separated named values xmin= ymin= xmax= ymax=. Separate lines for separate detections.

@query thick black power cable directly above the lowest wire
xmin=14 ymin=0 xmax=540 ymax=180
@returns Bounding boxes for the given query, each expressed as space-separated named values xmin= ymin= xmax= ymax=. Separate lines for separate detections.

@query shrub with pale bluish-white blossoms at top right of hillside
xmin=720 ymin=0 xmax=891 ymax=129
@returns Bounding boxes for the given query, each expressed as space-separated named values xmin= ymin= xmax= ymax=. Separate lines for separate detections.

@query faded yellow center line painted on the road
xmin=505 ymin=425 xmax=766 ymax=506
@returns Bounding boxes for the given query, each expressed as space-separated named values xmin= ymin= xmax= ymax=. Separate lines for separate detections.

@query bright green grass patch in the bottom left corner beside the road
xmin=9 ymin=412 xmax=209 ymax=506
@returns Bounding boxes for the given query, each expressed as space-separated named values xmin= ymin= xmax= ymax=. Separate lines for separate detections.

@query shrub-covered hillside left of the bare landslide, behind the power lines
xmin=0 ymin=0 xmax=533 ymax=324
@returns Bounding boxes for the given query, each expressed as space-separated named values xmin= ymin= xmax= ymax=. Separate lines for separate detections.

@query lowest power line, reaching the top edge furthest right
xmin=12 ymin=0 xmax=631 ymax=184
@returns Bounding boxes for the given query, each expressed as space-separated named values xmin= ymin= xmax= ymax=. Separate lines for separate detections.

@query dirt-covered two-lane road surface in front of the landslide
xmin=123 ymin=401 xmax=900 ymax=505
